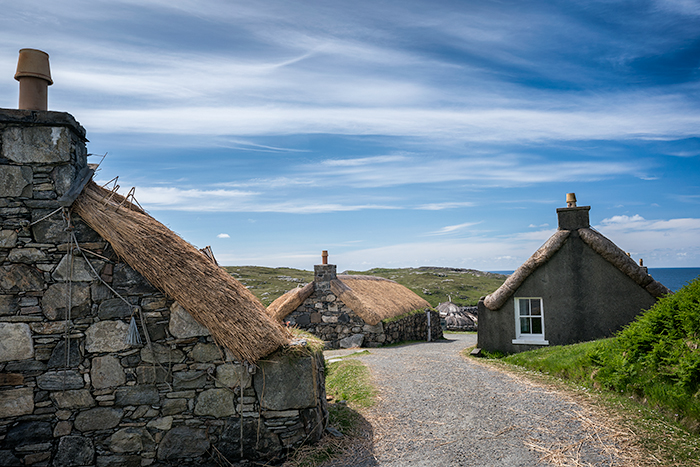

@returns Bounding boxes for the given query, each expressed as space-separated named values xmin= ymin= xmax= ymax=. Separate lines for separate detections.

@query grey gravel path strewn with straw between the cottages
xmin=327 ymin=334 xmax=634 ymax=467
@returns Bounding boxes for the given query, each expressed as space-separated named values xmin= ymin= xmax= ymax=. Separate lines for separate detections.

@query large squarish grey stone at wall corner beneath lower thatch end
xmin=253 ymin=356 xmax=318 ymax=410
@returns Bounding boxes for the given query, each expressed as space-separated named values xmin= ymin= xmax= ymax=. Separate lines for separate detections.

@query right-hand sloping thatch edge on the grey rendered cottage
xmin=578 ymin=228 xmax=671 ymax=298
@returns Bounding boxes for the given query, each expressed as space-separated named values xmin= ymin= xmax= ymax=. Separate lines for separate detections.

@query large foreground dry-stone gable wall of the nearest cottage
xmin=0 ymin=110 xmax=327 ymax=466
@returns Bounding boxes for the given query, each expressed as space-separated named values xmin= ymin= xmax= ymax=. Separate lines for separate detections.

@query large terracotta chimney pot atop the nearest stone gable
xmin=15 ymin=49 xmax=53 ymax=110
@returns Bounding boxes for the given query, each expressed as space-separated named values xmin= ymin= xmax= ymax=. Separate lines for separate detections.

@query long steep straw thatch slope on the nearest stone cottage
xmin=73 ymin=182 xmax=289 ymax=363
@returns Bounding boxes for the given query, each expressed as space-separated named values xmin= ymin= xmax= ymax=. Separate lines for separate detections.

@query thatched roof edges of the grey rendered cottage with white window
xmin=484 ymin=228 xmax=671 ymax=310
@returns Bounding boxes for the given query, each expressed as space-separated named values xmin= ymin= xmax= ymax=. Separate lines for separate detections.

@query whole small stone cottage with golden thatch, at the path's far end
xmin=267 ymin=251 xmax=442 ymax=349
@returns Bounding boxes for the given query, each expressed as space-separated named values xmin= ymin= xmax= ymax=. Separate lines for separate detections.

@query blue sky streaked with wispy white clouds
xmin=0 ymin=0 xmax=700 ymax=270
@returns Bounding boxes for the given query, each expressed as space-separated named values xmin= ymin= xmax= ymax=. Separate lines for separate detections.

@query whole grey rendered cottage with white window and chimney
xmin=477 ymin=193 xmax=670 ymax=353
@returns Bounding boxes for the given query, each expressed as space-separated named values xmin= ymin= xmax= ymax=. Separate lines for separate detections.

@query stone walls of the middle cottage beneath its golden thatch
xmin=285 ymin=290 xmax=442 ymax=349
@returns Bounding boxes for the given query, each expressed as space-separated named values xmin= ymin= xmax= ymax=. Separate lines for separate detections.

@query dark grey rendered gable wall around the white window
xmin=477 ymin=230 xmax=656 ymax=353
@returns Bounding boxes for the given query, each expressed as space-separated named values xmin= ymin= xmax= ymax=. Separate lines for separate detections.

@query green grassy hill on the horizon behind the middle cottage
xmin=224 ymin=266 xmax=507 ymax=307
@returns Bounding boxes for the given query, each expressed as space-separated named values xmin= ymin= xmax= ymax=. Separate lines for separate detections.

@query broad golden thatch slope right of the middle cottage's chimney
xmin=331 ymin=275 xmax=430 ymax=325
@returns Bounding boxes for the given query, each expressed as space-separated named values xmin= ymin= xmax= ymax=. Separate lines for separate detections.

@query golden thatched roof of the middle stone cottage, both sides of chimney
xmin=267 ymin=275 xmax=430 ymax=325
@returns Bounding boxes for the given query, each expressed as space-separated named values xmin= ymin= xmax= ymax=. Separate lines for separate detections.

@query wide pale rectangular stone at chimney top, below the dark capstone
xmin=2 ymin=126 xmax=72 ymax=164
